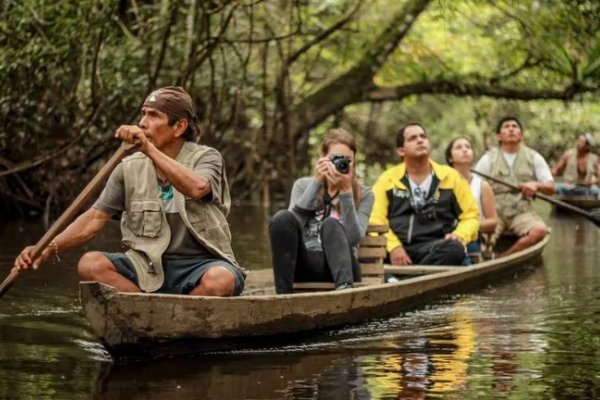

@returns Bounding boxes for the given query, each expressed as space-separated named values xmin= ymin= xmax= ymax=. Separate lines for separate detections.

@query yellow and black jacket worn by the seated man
xmin=369 ymin=160 xmax=479 ymax=252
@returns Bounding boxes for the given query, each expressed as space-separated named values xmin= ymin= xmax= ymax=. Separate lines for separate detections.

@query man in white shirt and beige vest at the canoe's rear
xmin=475 ymin=116 xmax=554 ymax=255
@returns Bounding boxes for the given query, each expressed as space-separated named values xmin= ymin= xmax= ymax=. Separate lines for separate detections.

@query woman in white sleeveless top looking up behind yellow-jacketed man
xmin=445 ymin=137 xmax=498 ymax=253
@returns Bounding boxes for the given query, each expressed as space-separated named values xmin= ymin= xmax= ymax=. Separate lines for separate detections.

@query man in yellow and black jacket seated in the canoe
xmin=370 ymin=123 xmax=479 ymax=265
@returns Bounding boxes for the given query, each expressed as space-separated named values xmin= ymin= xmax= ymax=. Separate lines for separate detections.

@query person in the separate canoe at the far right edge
xmin=552 ymin=133 xmax=600 ymax=197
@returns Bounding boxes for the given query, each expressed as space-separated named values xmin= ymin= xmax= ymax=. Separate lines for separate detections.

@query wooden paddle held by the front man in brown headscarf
xmin=0 ymin=143 xmax=136 ymax=298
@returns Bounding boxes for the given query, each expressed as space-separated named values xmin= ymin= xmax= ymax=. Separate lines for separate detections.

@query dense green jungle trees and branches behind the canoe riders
xmin=0 ymin=0 xmax=600 ymax=217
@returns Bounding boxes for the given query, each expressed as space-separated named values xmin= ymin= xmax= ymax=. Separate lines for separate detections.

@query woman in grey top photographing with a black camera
xmin=269 ymin=128 xmax=373 ymax=294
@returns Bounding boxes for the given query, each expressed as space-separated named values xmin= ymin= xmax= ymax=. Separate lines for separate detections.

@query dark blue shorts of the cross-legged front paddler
xmin=103 ymin=252 xmax=245 ymax=296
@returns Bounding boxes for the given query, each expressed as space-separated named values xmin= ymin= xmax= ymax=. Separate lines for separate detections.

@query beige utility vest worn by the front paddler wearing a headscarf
xmin=121 ymin=142 xmax=237 ymax=292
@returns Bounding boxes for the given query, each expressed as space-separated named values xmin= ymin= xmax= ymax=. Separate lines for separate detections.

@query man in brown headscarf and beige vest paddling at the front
xmin=14 ymin=86 xmax=245 ymax=296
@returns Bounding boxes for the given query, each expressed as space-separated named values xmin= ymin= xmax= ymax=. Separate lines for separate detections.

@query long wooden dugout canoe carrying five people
xmin=80 ymin=237 xmax=549 ymax=358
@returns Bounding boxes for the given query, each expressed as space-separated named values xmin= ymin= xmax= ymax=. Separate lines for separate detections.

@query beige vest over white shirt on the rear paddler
xmin=488 ymin=145 xmax=536 ymax=218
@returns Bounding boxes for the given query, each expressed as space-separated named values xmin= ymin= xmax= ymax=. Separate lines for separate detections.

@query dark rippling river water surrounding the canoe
xmin=0 ymin=207 xmax=600 ymax=400
